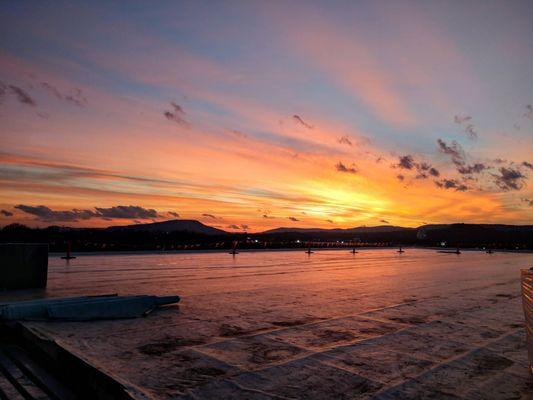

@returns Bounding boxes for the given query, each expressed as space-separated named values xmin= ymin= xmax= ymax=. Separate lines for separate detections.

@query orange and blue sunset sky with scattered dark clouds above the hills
xmin=0 ymin=1 xmax=533 ymax=232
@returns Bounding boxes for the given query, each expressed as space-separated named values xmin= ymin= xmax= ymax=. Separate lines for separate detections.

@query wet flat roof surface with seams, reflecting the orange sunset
xmin=9 ymin=249 xmax=533 ymax=399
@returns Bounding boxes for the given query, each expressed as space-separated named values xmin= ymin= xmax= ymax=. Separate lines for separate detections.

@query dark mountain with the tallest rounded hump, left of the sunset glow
xmin=106 ymin=219 xmax=228 ymax=235
